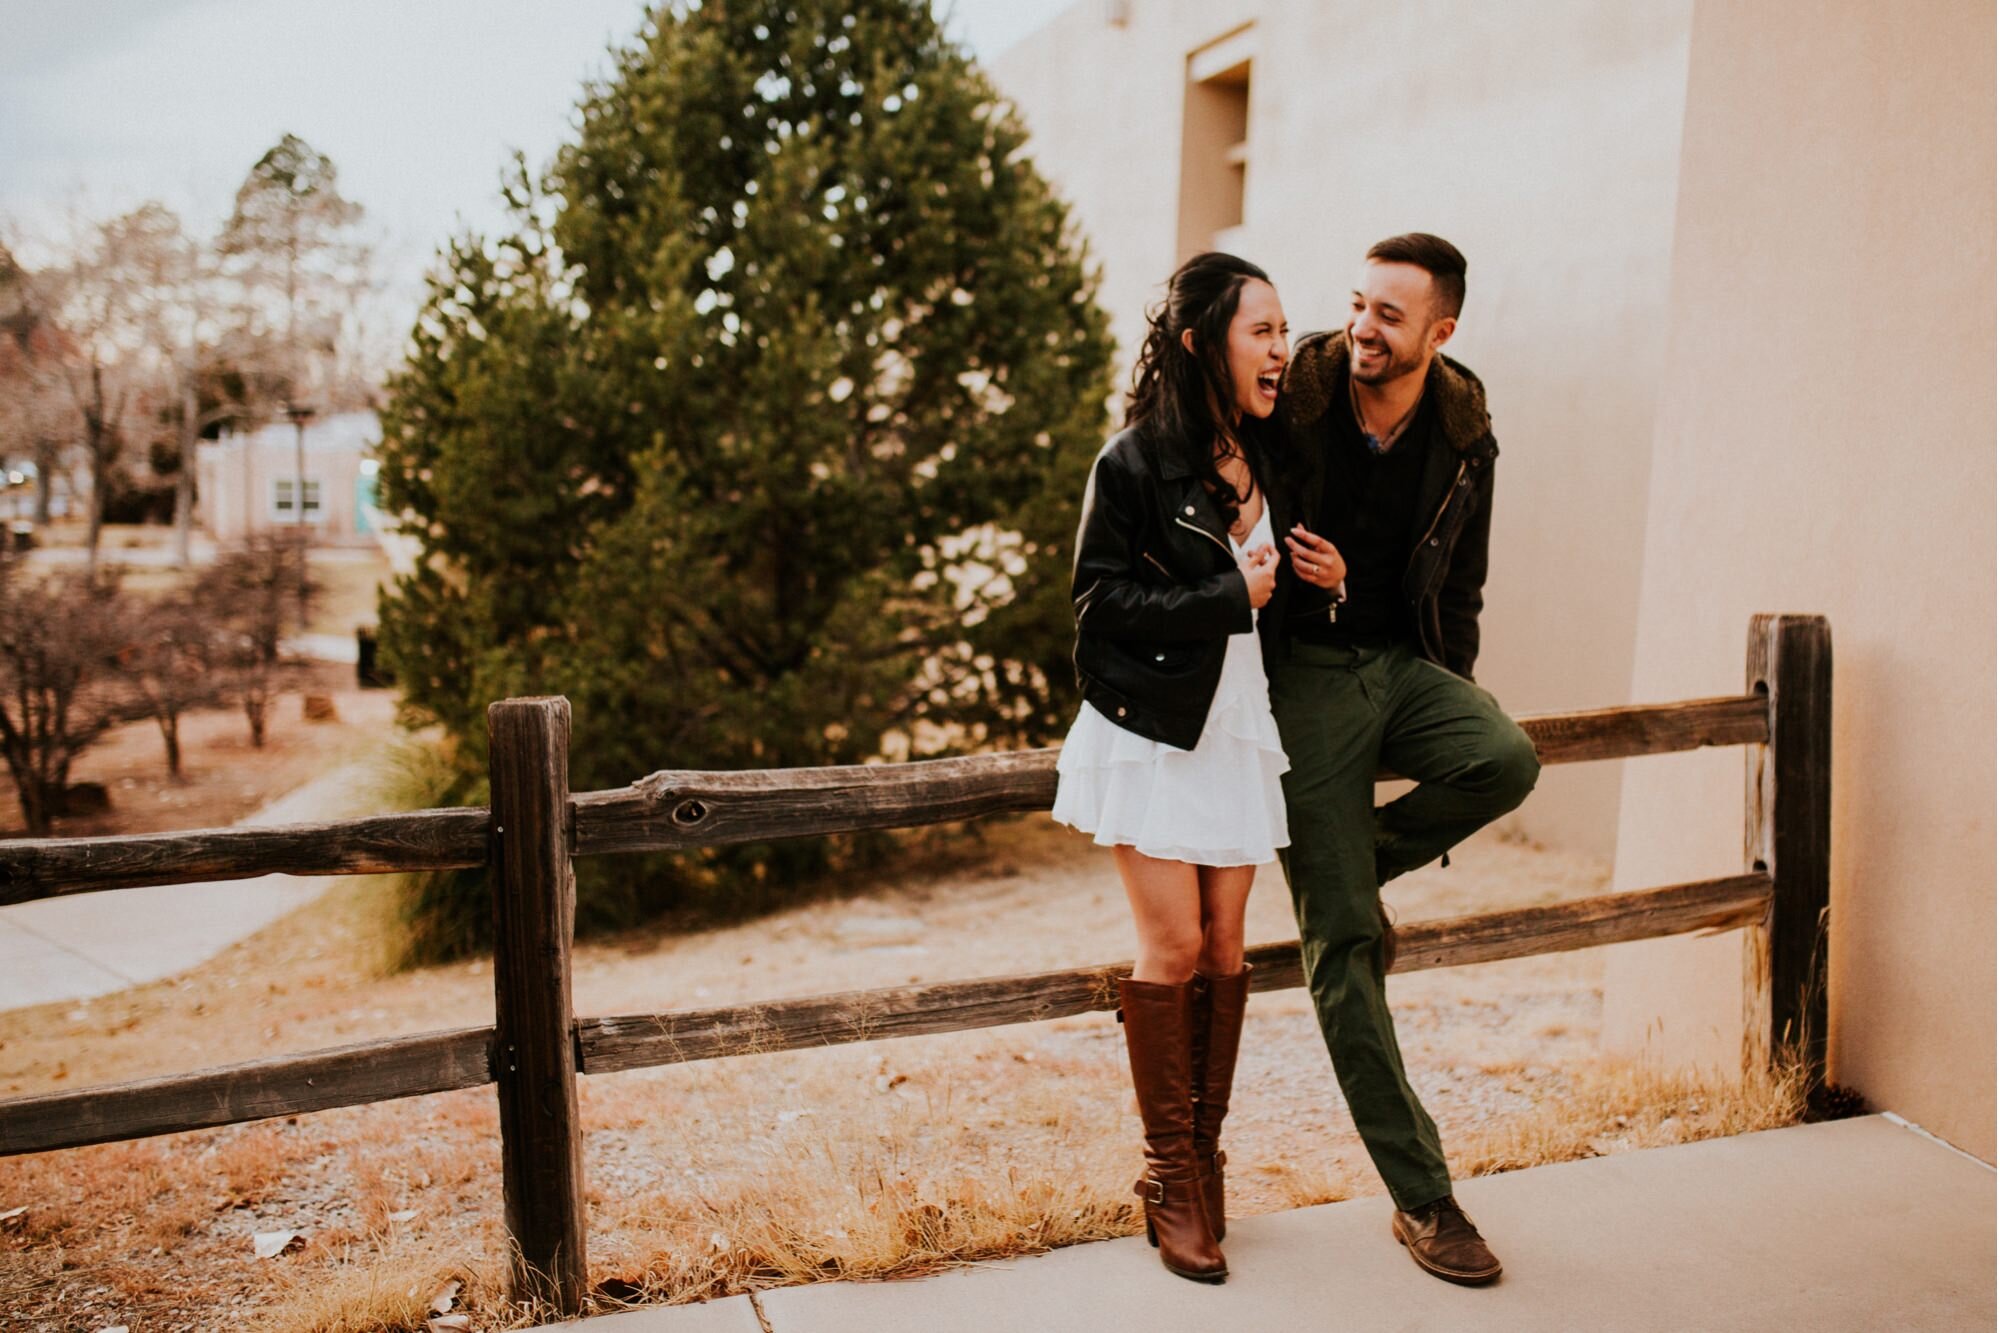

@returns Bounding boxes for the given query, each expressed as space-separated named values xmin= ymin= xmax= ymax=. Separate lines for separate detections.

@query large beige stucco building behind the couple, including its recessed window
xmin=994 ymin=0 xmax=1994 ymax=1161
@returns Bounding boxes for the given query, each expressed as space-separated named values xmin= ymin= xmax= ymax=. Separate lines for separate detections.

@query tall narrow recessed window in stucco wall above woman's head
xmin=1178 ymin=26 xmax=1256 ymax=258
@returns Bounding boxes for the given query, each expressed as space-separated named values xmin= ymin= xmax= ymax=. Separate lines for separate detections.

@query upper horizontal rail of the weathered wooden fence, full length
xmin=0 ymin=695 xmax=1768 ymax=907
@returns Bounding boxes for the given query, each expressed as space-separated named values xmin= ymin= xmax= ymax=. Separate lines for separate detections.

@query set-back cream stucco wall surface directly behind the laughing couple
xmin=992 ymin=0 xmax=1696 ymax=852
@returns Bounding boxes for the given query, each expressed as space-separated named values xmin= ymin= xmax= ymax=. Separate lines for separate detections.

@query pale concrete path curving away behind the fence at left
xmin=0 ymin=763 xmax=368 ymax=1011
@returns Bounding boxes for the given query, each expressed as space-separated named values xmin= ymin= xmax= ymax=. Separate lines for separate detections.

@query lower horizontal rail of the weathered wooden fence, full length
xmin=0 ymin=875 xmax=1772 ymax=1157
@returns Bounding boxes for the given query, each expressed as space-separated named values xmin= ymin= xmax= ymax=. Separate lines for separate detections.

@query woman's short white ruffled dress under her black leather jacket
xmin=1052 ymin=506 xmax=1292 ymax=867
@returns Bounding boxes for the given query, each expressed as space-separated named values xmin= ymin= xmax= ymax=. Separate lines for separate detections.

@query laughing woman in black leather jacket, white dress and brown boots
xmin=1054 ymin=252 xmax=1344 ymax=1281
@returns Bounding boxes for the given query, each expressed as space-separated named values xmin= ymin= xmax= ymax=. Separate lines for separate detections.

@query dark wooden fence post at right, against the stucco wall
xmin=1744 ymin=614 xmax=1834 ymax=1093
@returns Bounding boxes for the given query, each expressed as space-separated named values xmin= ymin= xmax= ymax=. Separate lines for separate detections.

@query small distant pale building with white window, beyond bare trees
xmin=194 ymin=412 xmax=382 ymax=544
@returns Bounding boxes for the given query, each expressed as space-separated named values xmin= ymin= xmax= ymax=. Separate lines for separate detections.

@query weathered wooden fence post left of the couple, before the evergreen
xmin=486 ymin=699 xmax=586 ymax=1315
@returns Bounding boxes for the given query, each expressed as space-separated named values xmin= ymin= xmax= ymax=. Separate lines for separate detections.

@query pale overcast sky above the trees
xmin=0 ymin=0 xmax=1074 ymax=280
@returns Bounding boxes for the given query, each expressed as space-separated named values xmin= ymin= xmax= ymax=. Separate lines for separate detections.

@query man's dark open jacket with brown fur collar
xmin=1260 ymin=330 xmax=1500 ymax=681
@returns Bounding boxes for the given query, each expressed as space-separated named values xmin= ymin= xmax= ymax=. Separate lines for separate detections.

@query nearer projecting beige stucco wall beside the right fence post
xmin=1606 ymin=0 xmax=1994 ymax=1161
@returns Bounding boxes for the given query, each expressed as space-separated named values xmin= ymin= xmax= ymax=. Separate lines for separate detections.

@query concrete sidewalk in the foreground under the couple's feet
xmin=562 ymin=1115 xmax=1994 ymax=1333
